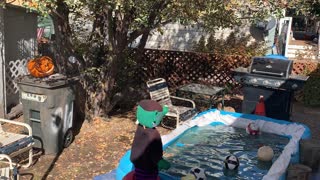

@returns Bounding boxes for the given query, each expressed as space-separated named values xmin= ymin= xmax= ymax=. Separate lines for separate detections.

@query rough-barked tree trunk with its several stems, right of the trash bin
xmin=51 ymin=0 xmax=168 ymax=116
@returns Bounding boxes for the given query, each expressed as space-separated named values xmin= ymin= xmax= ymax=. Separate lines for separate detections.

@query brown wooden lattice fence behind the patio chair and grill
xmin=132 ymin=49 xmax=317 ymax=92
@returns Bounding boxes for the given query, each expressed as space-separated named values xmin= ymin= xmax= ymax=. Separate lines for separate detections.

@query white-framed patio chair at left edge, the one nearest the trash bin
xmin=0 ymin=118 xmax=34 ymax=168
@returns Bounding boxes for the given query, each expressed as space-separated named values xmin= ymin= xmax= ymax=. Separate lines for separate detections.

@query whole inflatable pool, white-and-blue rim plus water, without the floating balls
xmin=109 ymin=109 xmax=311 ymax=180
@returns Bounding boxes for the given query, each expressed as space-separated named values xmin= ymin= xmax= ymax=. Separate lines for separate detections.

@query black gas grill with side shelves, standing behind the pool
xmin=234 ymin=57 xmax=308 ymax=120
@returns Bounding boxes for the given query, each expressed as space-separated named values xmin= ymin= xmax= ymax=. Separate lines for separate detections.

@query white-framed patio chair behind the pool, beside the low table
xmin=147 ymin=78 xmax=197 ymax=128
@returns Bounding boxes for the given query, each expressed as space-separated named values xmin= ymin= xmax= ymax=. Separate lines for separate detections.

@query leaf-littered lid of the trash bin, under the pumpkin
xmin=16 ymin=73 xmax=78 ymax=89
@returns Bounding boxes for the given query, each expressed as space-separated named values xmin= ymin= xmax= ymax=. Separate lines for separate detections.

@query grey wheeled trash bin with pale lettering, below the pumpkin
xmin=17 ymin=74 xmax=77 ymax=154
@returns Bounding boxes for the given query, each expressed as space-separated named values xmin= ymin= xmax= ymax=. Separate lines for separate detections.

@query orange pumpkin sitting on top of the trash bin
xmin=27 ymin=56 xmax=54 ymax=78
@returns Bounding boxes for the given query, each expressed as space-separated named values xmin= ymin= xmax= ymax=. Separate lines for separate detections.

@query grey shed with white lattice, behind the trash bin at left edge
xmin=0 ymin=4 xmax=37 ymax=117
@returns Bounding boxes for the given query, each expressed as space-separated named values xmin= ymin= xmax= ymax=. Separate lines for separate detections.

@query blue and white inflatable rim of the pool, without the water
xmin=95 ymin=109 xmax=311 ymax=180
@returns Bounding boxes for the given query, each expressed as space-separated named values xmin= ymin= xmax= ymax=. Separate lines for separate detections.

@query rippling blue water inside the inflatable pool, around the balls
xmin=164 ymin=125 xmax=289 ymax=179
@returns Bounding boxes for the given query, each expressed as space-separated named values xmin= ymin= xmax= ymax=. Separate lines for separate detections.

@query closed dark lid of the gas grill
xmin=249 ymin=57 xmax=292 ymax=78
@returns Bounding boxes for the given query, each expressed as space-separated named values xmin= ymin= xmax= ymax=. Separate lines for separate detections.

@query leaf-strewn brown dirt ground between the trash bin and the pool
xmin=3 ymin=95 xmax=320 ymax=180
